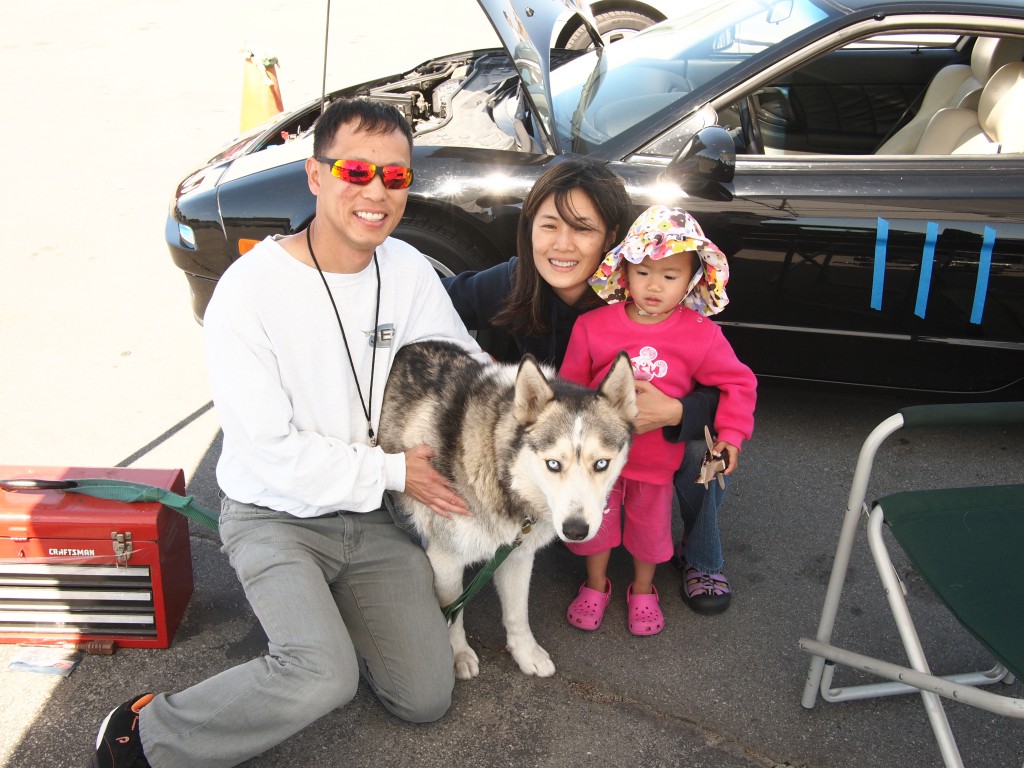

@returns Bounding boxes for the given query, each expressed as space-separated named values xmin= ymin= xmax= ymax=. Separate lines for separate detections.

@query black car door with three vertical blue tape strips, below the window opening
xmin=622 ymin=156 xmax=1024 ymax=391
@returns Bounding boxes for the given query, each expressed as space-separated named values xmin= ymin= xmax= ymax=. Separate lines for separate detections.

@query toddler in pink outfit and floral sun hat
xmin=559 ymin=206 xmax=757 ymax=635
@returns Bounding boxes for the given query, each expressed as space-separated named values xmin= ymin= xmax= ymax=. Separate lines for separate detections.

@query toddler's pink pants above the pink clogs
xmin=566 ymin=477 xmax=673 ymax=563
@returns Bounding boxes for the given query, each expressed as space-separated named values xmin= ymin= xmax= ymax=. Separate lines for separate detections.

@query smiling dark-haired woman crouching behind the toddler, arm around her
xmin=444 ymin=159 xmax=731 ymax=613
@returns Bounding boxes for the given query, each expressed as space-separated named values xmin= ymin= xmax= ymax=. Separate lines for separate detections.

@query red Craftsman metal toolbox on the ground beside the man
xmin=0 ymin=465 xmax=193 ymax=648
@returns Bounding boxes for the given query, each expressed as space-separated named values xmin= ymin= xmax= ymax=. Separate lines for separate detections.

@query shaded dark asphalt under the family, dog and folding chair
xmin=5 ymin=382 xmax=1024 ymax=768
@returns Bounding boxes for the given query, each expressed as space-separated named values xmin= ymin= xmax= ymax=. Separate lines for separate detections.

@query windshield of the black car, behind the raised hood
xmin=551 ymin=0 xmax=839 ymax=154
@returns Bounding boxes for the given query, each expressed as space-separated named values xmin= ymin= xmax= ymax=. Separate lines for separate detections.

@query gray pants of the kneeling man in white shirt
xmin=139 ymin=499 xmax=455 ymax=768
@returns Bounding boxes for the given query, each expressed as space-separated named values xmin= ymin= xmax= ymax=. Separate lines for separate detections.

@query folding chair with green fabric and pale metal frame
xmin=800 ymin=402 xmax=1024 ymax=766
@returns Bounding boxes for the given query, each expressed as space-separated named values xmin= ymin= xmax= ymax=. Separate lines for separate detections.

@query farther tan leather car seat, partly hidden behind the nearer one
xmin=874 ymin=37 xmax=1024 ymax=155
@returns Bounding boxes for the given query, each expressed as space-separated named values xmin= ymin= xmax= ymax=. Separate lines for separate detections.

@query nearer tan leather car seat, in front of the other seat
xmin=913 ymin=61 xmax=1024 ymax=155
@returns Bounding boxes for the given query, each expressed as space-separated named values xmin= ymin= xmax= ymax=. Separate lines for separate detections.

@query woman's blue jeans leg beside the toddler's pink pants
xmin=674 ymin=440 xmax=729 ymax=573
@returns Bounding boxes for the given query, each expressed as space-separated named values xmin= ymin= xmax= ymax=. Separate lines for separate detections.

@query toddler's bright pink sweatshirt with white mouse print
xmin=559 ymin=302 xmax=757 ymax=483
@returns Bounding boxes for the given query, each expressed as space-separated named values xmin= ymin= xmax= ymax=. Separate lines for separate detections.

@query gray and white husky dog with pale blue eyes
xmin=379 ymin=341 xmax=636 ymax=680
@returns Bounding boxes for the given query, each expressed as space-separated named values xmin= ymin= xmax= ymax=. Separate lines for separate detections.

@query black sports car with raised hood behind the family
xmin=166 ymin=0 xmax=1024 ymax=393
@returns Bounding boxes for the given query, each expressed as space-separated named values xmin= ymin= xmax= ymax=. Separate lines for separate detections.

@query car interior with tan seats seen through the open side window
xmin=719 ymin=37 xmax=1024 ymax=156
